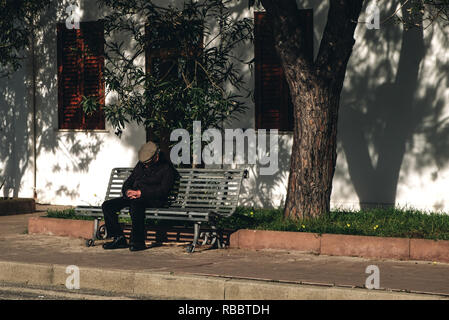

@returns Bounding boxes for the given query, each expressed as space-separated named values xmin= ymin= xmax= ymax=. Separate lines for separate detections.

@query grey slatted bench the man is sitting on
xmin=75 ymin=168 xmax=247 ymax=252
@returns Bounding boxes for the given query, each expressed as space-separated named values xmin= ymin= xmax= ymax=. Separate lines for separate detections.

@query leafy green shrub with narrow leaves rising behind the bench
xmin=99 ymin=0 xmax=253 ymax=146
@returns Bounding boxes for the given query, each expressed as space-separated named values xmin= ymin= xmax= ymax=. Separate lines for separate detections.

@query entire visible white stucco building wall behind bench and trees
xmin=0 ymin=0 xmax=449 ymax=211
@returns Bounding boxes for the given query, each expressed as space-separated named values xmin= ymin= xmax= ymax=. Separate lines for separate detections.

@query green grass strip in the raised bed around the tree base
xmin=47 ymin=207 xmax=449 ymax=240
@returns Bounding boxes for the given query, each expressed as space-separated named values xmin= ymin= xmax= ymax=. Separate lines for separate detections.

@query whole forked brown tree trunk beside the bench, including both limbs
xmin=262 ymin=0 xmax=363 ymax=219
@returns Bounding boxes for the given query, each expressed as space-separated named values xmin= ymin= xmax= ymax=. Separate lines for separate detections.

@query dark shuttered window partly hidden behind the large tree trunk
xmin=254 ymin=9 xmax=313 ymax=131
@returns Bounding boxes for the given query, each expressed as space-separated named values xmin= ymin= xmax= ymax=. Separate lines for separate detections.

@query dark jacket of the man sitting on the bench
xmin=122 ymin=152 xmax=178 ymax=202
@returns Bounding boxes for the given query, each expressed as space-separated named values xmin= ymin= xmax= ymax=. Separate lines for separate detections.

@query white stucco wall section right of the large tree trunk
xmin=332 ymin=1 xmax=449 ymax=211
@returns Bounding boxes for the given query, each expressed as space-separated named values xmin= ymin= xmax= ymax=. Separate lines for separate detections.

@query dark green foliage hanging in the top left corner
xmin=0 ymin=0 xmax=51 ymax=78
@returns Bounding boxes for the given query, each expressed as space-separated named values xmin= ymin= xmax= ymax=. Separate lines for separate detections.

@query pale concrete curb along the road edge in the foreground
xmin=0 ymin=261 xmax=449 ymax=300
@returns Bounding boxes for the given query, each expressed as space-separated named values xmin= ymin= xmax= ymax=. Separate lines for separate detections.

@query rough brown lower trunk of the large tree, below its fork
xmin=285 ymin=84 xmax=340 ymax=218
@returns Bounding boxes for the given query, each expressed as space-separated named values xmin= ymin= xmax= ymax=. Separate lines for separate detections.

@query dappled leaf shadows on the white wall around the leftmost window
xmin=0 ymin=0 xmax=105 ymax=198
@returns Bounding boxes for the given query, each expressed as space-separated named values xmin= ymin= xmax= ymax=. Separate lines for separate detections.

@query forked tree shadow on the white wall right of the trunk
xmin=336 ymin=2 xmax=449 ymax=208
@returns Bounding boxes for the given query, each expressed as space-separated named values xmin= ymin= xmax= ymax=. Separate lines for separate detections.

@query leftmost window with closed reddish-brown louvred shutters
xmin=57 ymin=21 xmax=105 ymax=129
